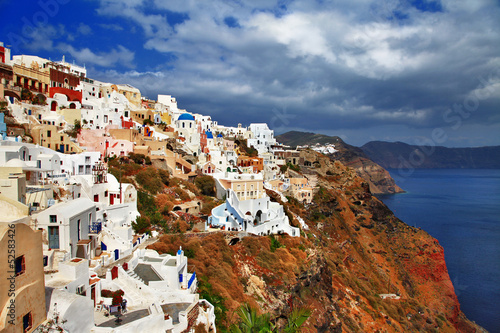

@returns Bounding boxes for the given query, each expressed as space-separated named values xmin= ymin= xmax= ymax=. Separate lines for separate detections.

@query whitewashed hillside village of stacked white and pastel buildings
xmin=0 ymin=44 xmax=335 ymax=333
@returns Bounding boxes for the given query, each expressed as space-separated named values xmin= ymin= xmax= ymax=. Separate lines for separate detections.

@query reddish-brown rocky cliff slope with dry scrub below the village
xmin=146 ymin=151 xmax=483 ymax=332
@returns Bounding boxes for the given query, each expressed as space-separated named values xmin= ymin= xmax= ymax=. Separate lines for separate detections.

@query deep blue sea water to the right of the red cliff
xmin=379 ymin=169 xmax=500 ymax=333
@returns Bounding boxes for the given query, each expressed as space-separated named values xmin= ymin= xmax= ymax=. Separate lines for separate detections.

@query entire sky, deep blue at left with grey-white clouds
xmin=0 ymin=0 xmax=500 ymax=147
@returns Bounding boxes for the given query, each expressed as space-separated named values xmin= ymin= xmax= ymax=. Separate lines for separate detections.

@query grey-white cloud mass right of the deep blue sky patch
xmin=90 ymin=0 xmax=500 ymax=144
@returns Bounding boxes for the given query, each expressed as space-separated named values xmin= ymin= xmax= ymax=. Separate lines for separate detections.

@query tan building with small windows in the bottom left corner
xmin=0 ymin=195 xmax=46 ymax=333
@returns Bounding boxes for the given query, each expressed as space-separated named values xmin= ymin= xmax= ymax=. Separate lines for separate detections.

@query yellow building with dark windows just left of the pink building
xmin=31 ymin=125 xmax=83 ymax=154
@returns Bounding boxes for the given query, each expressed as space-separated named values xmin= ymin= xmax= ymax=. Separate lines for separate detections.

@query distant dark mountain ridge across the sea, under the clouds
xmin=361 ymin=141 xmax=500 ymax=170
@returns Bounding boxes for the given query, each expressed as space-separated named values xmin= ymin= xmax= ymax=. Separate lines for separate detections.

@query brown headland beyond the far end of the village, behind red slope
xmin=276 ymin=132 xmax=404 ymax=194
